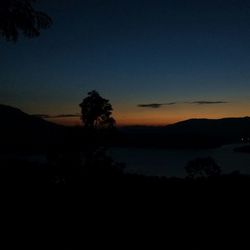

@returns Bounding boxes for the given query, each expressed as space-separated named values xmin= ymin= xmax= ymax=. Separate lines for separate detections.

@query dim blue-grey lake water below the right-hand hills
xmin=110 ymin=144 xmax=250 ymax=177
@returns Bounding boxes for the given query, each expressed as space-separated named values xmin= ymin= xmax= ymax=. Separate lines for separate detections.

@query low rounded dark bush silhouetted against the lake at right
xmin=185 ymin=157 xmax=221 ymax=178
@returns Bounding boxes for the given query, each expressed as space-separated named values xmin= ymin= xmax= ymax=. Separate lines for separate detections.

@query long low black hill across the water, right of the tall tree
xmin=116 ymin=117 xmax=250 ymax=148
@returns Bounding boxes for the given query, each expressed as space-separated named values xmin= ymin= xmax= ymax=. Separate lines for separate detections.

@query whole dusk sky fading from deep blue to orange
xmin=0 ymin=0 xmax=250 ymax=125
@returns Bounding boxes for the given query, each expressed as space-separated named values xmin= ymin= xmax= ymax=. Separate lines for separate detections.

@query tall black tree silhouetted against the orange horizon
xmin=80 ymin=90 xmax=115 ymax=129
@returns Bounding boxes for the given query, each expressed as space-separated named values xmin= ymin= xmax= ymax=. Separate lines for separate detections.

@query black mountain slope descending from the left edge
xmin=0 ymin=105 xmax=65 ymax=151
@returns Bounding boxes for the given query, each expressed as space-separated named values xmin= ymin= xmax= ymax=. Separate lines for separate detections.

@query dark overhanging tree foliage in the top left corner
xmin=0 ymin=0 xmax=52 ymax=42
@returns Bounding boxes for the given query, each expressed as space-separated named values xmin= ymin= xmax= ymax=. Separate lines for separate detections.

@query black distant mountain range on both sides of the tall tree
xmin=0 ymin=105 xmax=250 ymax=150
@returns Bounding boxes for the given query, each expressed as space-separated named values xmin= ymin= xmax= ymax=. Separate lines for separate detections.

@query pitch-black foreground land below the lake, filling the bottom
xmin=0 ymin=157 xmax=250 ymax=249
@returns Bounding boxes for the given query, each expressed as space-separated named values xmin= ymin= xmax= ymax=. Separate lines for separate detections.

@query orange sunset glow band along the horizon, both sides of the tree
xmin=44 ymin=103 xmax=250 ymax=126
